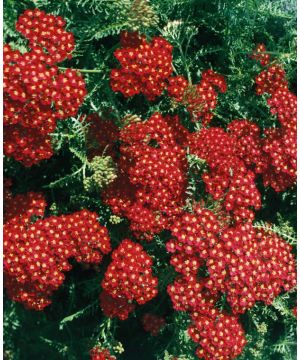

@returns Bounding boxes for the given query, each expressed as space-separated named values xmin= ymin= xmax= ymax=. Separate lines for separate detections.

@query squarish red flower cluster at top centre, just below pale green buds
xmin=110 ymin=33 xmax=173 ymax=100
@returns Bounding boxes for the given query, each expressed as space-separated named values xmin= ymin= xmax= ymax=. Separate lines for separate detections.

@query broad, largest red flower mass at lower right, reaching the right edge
xmin=166 ymin=200 xmax=296 ymax=313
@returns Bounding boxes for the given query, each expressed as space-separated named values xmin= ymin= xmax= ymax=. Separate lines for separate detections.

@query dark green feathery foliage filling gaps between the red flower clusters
xmin=4 ymin=0 xmax=296 ymax=360
